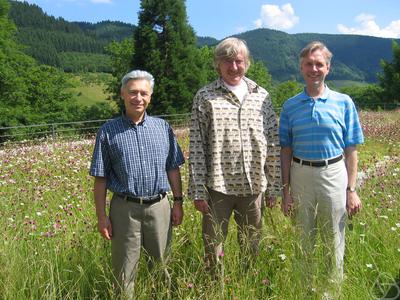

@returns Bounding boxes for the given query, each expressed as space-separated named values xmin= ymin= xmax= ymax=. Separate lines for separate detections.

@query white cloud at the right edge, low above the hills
xmin=337 ymin=13 xmax=400 ymax=38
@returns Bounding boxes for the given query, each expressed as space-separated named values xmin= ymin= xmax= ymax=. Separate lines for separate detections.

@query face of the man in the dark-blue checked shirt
xmin=121 ymin=79 xmax=151 ymax=119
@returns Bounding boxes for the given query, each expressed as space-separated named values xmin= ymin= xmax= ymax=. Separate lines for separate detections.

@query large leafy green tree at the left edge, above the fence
xmin=0 ymin=0 xmax=86 ymax=139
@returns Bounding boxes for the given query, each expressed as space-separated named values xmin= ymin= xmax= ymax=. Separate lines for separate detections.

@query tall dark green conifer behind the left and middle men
xmin=131 ymin=0 xmax=207 ymax=114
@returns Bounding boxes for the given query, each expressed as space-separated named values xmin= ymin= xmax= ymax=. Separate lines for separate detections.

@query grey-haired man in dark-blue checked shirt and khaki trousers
xmin=90 ymin=70 xmax=184 ymax=298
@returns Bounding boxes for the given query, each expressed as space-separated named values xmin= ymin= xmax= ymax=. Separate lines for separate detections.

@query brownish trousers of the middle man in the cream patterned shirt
xmin=203 ymin=190 xmax=263 ymax=272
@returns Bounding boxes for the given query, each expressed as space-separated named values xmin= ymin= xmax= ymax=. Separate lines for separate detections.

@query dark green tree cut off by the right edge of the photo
xmin=379 ymin=41 xmax=400 ymax=104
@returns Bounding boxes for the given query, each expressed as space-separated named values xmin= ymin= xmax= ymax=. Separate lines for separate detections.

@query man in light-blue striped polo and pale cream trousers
xmin=279 ymin=42 xmax=364 ymax=296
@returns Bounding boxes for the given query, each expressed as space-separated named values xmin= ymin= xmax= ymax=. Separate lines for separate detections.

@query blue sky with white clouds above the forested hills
xmin=15 ymin=0 xmax=400 ymax=39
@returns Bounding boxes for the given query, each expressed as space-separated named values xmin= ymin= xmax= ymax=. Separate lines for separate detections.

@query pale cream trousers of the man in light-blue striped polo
xmin=290 ymin=160 xmax=347 ymax=283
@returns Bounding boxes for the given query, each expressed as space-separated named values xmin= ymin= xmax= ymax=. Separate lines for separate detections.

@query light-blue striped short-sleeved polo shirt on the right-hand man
xmin=279 ymin=86 xmax=364 ymax=160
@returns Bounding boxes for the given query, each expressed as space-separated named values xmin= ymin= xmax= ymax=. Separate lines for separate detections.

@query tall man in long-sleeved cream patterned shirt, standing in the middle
xmin=189 ymin=38 xmax=280 ymax=275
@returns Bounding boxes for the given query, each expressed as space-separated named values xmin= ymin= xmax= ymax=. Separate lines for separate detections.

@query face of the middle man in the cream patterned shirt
xmin=219 ymin=53 xmax=246 ymax=85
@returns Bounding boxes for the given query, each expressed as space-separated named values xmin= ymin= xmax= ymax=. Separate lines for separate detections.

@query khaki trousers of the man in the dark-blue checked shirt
xmin=110 ymin=194 xmax=172 ymax=298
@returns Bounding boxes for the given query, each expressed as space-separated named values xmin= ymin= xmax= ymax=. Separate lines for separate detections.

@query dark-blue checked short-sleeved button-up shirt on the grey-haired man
xmin=89 ymin=114 xmax=184 ymax=197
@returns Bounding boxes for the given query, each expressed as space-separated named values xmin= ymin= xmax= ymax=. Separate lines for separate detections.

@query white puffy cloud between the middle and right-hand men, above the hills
xmin=254 ymin=3 xmax=299 ymax=30
